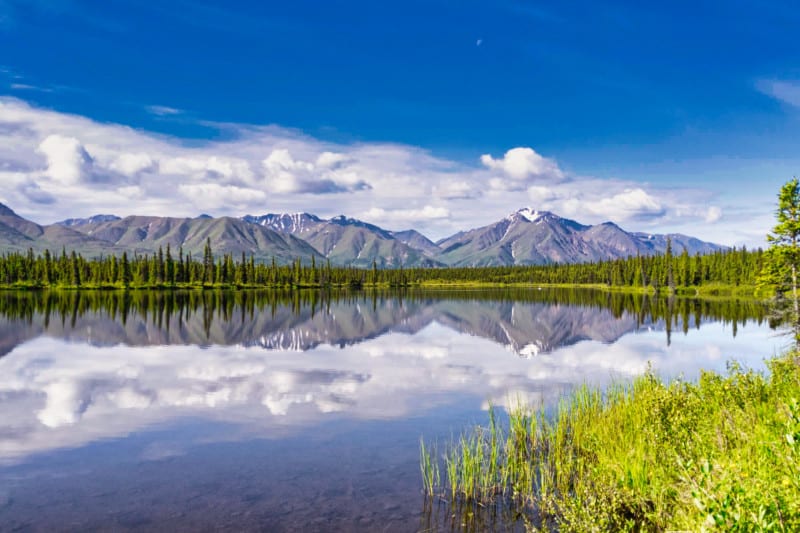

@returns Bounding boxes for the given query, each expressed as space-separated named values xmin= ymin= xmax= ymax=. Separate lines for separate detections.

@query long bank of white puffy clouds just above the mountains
xmin=0 ymin=98 xmax=736 ymax=238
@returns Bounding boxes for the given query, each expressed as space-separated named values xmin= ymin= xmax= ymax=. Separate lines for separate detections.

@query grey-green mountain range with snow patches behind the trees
xmin=0 ymin=204 xmax=724 ymax=268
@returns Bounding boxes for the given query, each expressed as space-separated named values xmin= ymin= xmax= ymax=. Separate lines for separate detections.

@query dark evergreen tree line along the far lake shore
xmin=0 ymin=241 xmax=767 ymax=291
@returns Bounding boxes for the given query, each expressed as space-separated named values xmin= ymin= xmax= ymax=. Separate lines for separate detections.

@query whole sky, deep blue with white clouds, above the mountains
xmin=0 ymin=0 xmax=800 ymax=244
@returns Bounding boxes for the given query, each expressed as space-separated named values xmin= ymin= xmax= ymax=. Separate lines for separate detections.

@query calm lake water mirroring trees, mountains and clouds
xmin=0 ymin=290 xmax=787 ymax=531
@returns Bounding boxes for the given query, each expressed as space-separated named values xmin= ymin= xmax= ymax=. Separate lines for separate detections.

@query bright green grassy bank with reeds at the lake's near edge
xmin=421 ymin=354 xmax=800 ymax=531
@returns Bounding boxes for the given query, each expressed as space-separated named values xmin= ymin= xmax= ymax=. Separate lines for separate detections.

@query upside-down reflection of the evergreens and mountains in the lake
xmin=0 ymin=289 xmax=765 ymax=356
